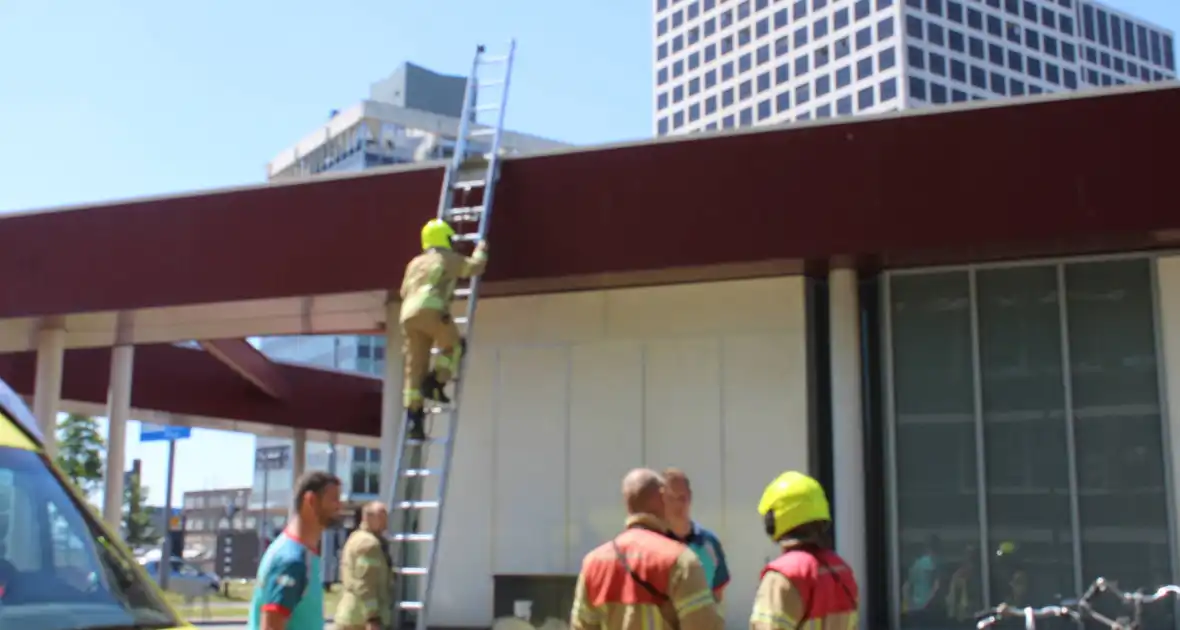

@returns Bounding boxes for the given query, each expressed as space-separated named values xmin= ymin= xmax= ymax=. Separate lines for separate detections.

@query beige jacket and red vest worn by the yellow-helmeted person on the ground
xmin=749 ymin=547 xmax=860 ymax=630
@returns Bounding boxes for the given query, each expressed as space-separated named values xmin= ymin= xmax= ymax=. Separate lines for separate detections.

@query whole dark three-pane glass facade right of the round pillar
xmin=885 ymin=258 xmax=1173 ymax=629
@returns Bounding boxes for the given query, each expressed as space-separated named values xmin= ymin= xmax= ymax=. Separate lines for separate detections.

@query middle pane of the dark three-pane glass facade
xmin=976 ymin=267 xmax=1075 ymax=606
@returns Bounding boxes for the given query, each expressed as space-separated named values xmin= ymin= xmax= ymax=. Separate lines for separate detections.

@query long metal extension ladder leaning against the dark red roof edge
xmin=389 ymin=40 xmax=516 ymax=630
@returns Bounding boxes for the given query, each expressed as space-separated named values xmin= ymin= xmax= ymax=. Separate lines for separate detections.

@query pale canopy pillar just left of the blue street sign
xmin=103 ymin=344 xmax=136 ymax=532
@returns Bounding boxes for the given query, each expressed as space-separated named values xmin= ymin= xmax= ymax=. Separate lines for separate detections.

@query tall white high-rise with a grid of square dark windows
xmin=653 ymin=0 xmax=1175 ymax=136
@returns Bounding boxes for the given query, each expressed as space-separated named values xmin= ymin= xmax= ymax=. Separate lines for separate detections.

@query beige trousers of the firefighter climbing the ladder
xmin=401 ymin=310 xmax=461 ymax=409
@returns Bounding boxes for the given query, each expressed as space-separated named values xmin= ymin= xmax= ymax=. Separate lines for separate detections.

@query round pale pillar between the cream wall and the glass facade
xmin=827 ymin=269 xmax=873 ymax=623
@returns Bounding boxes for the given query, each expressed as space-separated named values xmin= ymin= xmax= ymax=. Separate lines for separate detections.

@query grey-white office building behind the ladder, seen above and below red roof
xmin=250 ymin=64 xmax=566 ymax=514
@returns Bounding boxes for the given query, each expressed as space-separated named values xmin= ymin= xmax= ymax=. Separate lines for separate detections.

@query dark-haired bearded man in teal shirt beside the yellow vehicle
xmin=247 ymin=472 xmax=340 ymax=630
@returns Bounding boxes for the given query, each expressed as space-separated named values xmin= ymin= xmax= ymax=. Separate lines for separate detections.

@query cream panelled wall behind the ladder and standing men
xmin=420 ymin=277 xmax=808 ymax=628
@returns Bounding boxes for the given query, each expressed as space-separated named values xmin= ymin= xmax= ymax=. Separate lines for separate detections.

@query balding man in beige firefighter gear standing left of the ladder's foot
xmin=335 ymin=501 xmax=393 ymax=630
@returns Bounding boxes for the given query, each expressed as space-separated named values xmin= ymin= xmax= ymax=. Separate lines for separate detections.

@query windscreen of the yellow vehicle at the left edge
xmin=0 ymin=443 xmax=181 ymax=630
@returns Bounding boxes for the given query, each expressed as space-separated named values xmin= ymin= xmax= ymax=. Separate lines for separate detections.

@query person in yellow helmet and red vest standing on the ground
xmin=749 ymin=471 xmax=860 ymax=630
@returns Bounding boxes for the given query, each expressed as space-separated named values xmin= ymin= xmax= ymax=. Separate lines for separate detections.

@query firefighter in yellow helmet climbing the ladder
xmin=400 ymin=218 xmax=487 ymax=440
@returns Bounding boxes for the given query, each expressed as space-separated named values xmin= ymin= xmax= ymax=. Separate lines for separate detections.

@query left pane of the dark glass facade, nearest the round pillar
xmin=890 ymin=271 xmax=983 ymax=628
